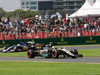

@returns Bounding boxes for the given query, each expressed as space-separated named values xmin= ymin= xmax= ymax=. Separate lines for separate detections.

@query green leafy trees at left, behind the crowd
xmin=0 ymin=8 xmax=40 ymax=19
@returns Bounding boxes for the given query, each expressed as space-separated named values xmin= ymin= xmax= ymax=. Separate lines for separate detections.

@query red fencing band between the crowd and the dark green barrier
xmin=0 ymin=30 xmax=100 ymax=40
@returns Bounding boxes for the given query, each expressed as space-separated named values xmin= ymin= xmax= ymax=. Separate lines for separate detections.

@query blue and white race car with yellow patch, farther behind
xmin=3 ymin=41 xmax=40 ymax=53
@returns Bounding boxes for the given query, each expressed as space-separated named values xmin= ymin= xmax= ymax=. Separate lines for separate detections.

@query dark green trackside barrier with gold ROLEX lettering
xmin=0 ymin=36 xmax=100 ymax=48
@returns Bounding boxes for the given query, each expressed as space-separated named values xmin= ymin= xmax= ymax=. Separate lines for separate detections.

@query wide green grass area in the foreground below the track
xmin=0 ymin=61 xmax=100 ymax=75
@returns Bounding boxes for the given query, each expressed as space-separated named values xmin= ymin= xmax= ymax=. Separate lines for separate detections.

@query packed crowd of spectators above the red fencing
xmin=0 ymin=16 xmax=100 ymax=39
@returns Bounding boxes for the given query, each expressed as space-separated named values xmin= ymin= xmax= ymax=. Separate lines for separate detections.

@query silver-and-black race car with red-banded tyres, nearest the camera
xmin=27 ymin=45 xmax=83 ymax=58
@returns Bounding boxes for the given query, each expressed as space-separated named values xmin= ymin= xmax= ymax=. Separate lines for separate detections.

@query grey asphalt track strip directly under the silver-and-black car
xmin=0 ymin=57 xmax=100 ymax=63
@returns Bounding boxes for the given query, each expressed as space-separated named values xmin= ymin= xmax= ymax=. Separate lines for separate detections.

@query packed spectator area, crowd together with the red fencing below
xmin=0 ymin=15 xmax=100 ymax=40
